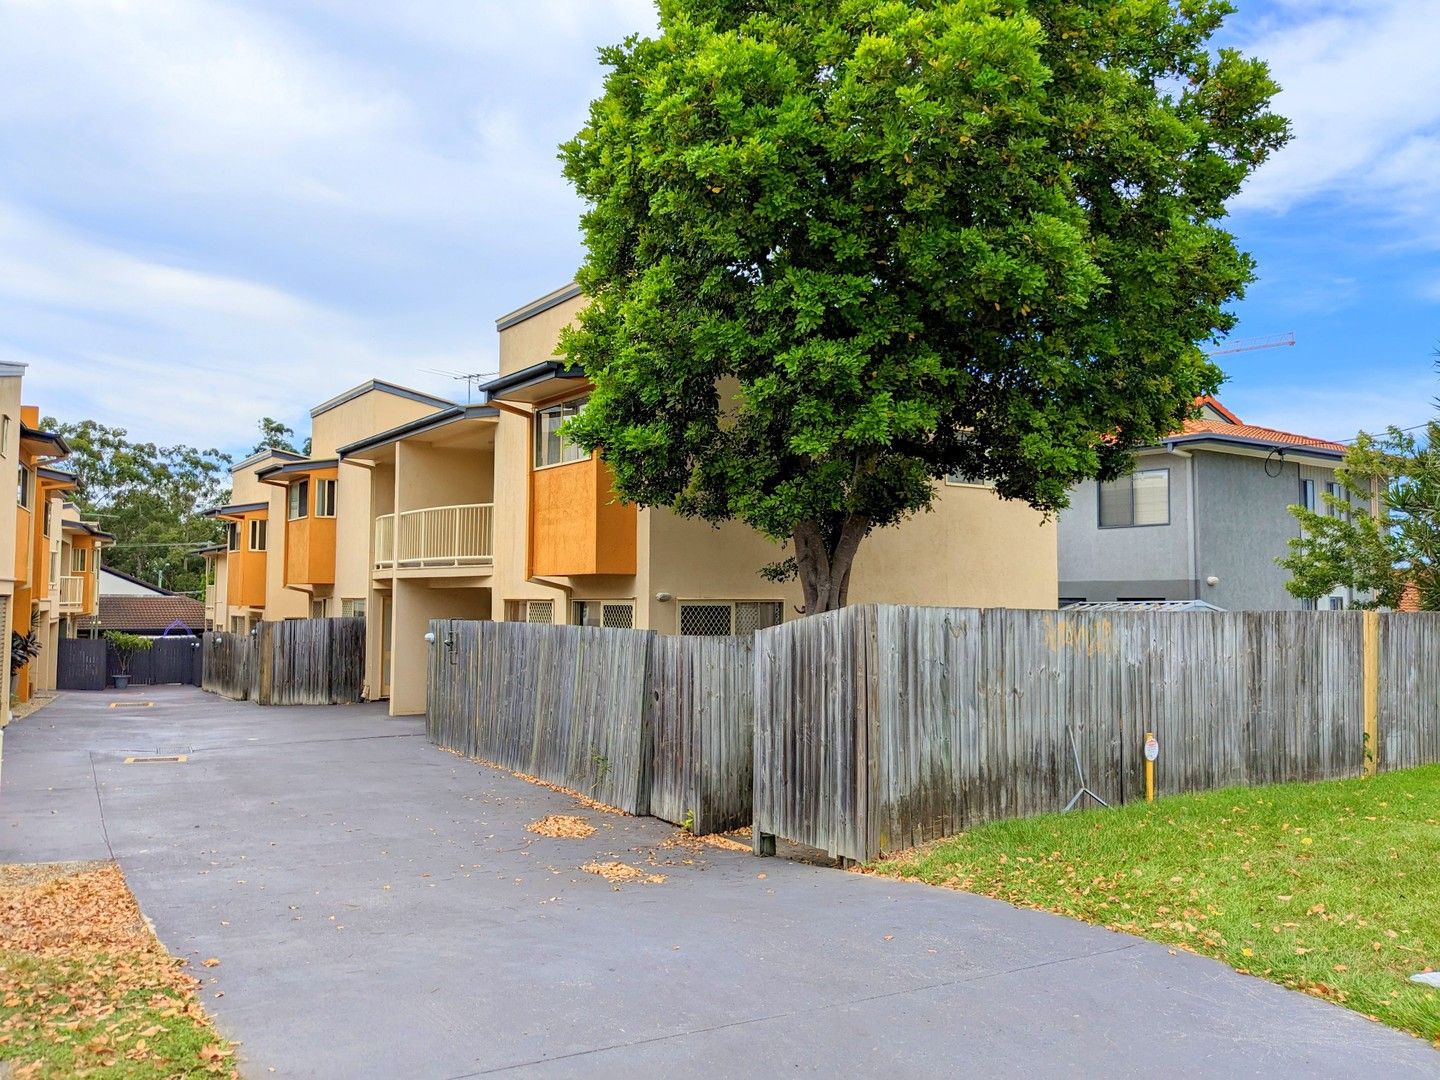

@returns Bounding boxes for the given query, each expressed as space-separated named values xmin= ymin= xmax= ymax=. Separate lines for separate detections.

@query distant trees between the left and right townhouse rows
xmin=43 ymin=418 xmax=230 ymax=593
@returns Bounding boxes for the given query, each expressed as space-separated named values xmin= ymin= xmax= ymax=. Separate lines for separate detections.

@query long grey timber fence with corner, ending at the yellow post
xmin=755 ymin=605 xmax=1370 ymax=860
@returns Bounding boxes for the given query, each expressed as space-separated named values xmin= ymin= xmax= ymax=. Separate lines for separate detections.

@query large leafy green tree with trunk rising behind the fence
xmin=562 ymin=0 xmax=1287 ymax=612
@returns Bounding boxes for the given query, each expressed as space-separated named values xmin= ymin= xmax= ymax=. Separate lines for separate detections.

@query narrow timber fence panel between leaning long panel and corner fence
xmin=647 ymin=635 xmax=755 ymax=835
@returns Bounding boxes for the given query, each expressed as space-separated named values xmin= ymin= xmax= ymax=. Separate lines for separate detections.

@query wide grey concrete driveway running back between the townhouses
xmin=0 ymin=687 xmax=1440 ymax=1079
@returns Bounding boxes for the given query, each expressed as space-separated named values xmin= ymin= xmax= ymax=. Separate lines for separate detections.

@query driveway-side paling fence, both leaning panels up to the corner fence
xmin=426 ymin=621 xmax=753 ymax=832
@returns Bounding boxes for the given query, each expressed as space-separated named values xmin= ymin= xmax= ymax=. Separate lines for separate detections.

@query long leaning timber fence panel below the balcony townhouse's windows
xmin=426 ymin=619 xmax=654 ymax=814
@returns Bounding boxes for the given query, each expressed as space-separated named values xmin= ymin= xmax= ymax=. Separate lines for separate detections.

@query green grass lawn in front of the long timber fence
xmin=870 ymin=766 xmax=1440 ymax=1045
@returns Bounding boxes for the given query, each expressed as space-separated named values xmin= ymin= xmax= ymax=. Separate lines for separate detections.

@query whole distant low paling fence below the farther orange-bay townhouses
xmin=202 ymin=618 xmax=364 ymax=706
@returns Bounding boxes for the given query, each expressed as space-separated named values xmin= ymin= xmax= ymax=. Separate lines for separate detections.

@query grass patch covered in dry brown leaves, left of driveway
xmin=0 ymin=863 xmax=236 ymax=1079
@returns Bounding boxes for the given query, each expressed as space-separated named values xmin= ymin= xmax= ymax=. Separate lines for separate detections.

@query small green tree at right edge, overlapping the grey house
xmin=1277 ymin=420 xmax=1440 ymax=611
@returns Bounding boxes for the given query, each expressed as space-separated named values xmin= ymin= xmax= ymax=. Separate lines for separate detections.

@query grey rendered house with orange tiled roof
xmin=1058 ymin=397 xmax=1351 ymax=611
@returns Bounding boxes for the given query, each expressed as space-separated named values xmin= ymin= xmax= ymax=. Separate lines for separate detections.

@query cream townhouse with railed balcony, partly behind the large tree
xmin=340 ymin=285 xmax=1057 ymax=714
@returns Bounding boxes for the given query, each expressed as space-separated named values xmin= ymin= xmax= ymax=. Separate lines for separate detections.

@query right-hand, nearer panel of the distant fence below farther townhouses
xmin=252 ymin=618 xmax=364 ymax=706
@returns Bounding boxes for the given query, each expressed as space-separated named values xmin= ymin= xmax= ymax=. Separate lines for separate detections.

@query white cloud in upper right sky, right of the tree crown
xmin=1237 ymin=0 xmax=1440 ymax=224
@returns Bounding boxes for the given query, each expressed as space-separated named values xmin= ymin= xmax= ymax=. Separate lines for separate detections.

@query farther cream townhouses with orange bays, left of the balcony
xmin=202 ymin=379 xmax=451 ymax=632
